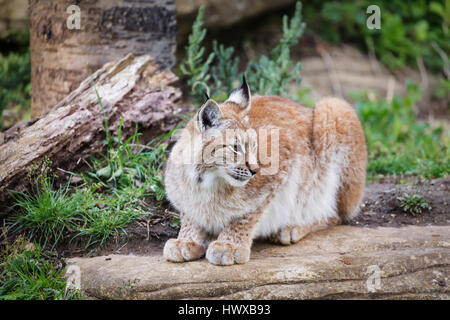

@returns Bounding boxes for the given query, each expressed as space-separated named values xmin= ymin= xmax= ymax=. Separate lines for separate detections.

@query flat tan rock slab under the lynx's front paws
xmin=69 ymin=226 xmax=450 ymax=299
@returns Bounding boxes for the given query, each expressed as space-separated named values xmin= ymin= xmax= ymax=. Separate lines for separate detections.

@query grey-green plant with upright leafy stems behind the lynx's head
xmin=180 ymin=2 xmax=305 ymax=102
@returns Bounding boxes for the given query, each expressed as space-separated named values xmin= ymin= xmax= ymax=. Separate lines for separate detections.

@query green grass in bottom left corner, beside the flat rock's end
xmin=0 ymin=238 xmax=84 ymax=300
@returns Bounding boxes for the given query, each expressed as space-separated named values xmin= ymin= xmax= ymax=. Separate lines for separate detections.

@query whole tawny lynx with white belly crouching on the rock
xmin=164 ymin=78 xmax=367 ymax=265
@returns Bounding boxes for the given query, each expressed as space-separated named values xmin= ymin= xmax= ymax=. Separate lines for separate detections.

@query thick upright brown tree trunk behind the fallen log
xmin=29 ymin=0 xmax=176 ymax=117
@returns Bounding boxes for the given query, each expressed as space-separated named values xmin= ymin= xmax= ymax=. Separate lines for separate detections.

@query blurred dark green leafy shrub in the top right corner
xmin=310 ymin=0 xmax=450 ymax=72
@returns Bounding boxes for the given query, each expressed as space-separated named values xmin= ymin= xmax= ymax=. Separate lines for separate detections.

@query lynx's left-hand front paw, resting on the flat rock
xmin=163 ymin=239 xmax=205 ymax=262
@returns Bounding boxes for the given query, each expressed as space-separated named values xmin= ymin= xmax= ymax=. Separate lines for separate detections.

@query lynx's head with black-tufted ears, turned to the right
xmin=195 ymin=77 xmax=259 ymax=187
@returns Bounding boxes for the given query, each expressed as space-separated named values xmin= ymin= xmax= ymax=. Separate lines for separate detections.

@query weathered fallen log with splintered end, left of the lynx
xmin=0 ymin=54 xmax=181 ymax=204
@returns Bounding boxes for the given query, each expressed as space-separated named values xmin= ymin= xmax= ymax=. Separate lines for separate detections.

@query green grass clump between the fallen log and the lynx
xmin=9 ymin=123 xmax=172 ymax=248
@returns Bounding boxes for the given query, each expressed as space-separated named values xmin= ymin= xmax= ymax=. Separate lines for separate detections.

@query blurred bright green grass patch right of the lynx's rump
xmin=354 ymin=83 xmax=450 ymax=178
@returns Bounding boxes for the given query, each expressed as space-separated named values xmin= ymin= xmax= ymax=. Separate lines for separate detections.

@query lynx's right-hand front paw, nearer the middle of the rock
xmin=206 ymin=240 xmax=250 ymax=266
